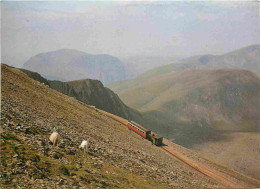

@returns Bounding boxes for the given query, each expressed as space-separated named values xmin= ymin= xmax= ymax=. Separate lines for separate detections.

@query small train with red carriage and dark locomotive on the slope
xmin=127 ymin=121 xmax=163 ymax=146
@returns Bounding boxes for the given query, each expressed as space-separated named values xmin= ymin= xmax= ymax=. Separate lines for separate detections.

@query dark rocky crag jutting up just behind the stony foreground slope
xmin=16 ymin=66 xmax=146 ymax=123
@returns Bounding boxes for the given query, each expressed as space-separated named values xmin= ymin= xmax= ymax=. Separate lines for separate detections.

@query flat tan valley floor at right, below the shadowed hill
xmin=192 ymin=132 xmax=260 ymax=179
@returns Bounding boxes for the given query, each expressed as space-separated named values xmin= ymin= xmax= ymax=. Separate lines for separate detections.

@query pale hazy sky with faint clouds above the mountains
xmin=1 ymin=1 xmax=260 ymax=66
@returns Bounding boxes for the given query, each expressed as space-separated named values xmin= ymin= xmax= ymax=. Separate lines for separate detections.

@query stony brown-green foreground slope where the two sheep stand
xmin=1 ymin=65 xmax=223 ymax=188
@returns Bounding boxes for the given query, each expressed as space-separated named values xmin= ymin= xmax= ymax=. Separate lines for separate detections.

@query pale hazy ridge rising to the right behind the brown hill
xmin=107 ymin=45 xmax=260 ymax=93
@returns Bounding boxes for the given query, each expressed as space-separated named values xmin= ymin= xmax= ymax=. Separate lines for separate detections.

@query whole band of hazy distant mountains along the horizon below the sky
xmin=23 ymin=45 xmax=260 ymax=85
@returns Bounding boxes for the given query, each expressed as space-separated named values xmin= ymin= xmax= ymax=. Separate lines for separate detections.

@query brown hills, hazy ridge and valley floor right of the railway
xmin=107 ymin=45 xmax=260 ymax=179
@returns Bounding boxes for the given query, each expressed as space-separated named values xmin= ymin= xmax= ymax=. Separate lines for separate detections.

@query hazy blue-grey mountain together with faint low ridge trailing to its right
xmin=23 ymin=49 xmax=182 ymax=84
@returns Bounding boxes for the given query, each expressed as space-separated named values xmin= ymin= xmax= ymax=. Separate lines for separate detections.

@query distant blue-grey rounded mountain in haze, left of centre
xmin=23 ymin=49 xmax=126 ymax=83
